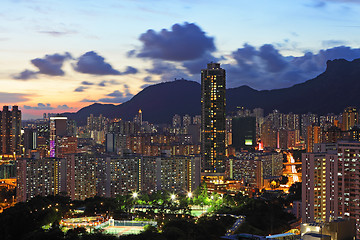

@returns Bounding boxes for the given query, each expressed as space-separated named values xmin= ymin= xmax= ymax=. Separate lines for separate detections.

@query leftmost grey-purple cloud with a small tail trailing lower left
xmin=13 ymin=52 xmax=72 ymax=80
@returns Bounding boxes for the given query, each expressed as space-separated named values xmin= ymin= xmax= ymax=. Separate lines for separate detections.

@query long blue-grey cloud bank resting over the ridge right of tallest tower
xmin=222 ymin=44 xmax=360 ymax=89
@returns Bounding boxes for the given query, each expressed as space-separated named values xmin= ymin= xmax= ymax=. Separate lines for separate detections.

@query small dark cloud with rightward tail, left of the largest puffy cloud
xmin=73 ymin=51 xmax=137 ymax=75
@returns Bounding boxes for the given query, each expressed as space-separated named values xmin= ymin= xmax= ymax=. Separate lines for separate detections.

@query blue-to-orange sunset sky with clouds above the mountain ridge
xmin=0 ymin=0 xmax=360 ymax=119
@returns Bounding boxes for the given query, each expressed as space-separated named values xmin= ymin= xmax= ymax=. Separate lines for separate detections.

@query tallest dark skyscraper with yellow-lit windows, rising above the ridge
xmin=201 ymin=63 xmax=226 ymax=176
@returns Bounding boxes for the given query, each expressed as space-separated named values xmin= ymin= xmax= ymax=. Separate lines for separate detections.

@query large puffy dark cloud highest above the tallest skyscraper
xmin=134 ymin=22 xmax=216 ymax=61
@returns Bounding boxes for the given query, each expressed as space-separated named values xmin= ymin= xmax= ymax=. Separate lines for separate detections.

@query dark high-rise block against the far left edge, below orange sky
xmin=0 ymin=106 xmax=21 ymax=155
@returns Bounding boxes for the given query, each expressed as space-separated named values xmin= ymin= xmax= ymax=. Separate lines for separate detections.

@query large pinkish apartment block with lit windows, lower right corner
xmin=302 ymin=141 xmax=360 ymax=238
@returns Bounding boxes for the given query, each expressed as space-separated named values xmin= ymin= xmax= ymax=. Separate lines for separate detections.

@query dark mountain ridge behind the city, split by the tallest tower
xmin=64 ymin=59 xmax=360 ymax=123
